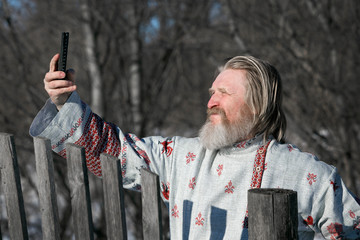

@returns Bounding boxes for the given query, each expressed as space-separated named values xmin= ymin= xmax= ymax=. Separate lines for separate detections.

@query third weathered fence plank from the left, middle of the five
xmin=66 ymin=143 xmax=94 ymax=240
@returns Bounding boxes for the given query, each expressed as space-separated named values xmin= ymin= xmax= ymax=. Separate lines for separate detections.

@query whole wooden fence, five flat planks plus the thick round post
xmin=0 ymin=133 xmax=297 ymax=240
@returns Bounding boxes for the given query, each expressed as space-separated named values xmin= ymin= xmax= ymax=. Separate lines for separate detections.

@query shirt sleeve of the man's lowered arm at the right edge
xmin=306 ymin=168 xmax=360 ymax=239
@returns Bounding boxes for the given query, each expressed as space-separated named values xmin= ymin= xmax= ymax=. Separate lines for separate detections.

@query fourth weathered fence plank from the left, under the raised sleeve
xmin=100 ymin=154 xmax=127 ymax=240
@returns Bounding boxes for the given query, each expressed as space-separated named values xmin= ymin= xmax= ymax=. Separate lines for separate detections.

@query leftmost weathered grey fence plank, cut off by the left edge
xmin=0 ymin=133 xmax=28 ymax=240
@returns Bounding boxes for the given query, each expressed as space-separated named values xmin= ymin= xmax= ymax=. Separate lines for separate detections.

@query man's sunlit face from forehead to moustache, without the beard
xmin=208 ymin=69 xmax=253 ymax=125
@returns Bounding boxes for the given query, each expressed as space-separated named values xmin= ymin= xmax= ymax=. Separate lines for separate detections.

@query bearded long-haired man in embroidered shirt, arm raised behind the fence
xmin=30 ymin=55 xmax=360 ymax=239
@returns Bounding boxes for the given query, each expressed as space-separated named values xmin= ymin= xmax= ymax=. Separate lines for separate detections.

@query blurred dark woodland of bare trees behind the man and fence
xmin=0 ymin=0 xmax=360 ymax=239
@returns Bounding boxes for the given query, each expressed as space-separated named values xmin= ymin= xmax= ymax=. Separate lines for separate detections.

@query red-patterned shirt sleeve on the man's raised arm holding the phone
xmin=30 ymin=92 xmax=175 ymax=197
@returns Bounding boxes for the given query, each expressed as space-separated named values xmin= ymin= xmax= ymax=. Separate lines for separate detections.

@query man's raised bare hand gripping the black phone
xmin=44 ymin=54 xmax=76 ymax=110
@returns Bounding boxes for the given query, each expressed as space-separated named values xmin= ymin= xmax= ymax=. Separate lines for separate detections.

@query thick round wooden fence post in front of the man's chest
xmin=248 ymin=188 xmax=298 ymax=240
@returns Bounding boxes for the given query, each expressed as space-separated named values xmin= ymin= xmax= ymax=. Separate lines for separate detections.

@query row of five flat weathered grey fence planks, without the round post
xmin=0 ymin=133 xmax=162 ymax=240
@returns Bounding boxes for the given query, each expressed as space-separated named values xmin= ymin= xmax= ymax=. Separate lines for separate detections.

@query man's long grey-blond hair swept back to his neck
xmin=223 ymin=56 xmax=286 ymax=142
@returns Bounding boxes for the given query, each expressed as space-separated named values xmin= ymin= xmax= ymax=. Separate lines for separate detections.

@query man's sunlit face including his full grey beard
xmin=199 ymin=69 xmax=254 ymax=149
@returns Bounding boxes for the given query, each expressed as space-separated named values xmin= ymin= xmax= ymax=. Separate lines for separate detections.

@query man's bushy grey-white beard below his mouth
xmin=199 ymin=113 xmax=253 ymax=150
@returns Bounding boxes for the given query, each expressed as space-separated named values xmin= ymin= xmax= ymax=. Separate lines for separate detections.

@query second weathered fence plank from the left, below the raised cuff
xmin=34 ymin=138 xmax=60 ymax=240
